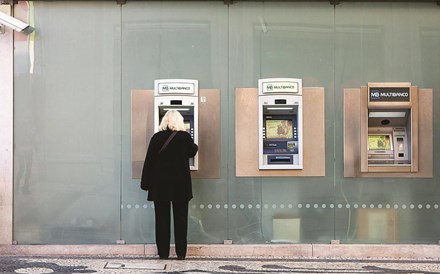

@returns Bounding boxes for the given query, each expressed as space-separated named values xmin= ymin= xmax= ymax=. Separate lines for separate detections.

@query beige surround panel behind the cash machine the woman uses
xmin=131 ymin=89 xmax=220 ymax=179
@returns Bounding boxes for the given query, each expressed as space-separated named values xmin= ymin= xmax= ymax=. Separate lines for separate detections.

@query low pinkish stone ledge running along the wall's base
xmin=0 ymin=244 xmax=440 ymax=260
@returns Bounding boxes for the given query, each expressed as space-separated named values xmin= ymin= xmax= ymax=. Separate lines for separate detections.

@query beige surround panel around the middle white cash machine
xmin=235 ymin=87 xmax=325 ymax=177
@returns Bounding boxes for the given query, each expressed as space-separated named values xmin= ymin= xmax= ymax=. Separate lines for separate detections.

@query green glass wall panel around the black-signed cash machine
xmin=335 ymin=3 xmax=440 ymax=243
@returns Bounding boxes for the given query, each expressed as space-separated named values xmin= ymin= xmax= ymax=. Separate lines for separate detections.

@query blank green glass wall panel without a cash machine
xmin=14 ymin=1 xmax=121 ymax=244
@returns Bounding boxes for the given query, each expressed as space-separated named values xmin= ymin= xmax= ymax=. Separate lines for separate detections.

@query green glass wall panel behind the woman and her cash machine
xmin=121 ymin=2 xmax=228 ymax=243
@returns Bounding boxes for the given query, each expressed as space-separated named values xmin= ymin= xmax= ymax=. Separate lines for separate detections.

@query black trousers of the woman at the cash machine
xmin=154 ymin=201 xmax=189 ymax=257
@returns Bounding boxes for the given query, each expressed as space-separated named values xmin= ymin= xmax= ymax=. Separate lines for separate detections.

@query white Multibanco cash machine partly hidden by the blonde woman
xmin=154 ymin=79 xmax=199 ymax=170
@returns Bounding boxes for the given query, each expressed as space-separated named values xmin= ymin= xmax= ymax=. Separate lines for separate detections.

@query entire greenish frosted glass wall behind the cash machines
xmin=14 ymin=1 xmax=440 ymax=244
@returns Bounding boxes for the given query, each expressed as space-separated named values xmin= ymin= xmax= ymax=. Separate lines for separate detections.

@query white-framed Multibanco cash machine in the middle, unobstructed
xmin=258 ymin=78 xmax=303 ymax=169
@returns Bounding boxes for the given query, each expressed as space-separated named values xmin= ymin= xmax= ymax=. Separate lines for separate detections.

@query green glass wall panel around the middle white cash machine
xmin=228 ymin=3 xmax=334 ymax=243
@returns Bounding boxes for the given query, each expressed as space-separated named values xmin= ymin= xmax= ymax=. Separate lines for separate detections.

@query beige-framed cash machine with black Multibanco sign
xmin=361 ymin=83 xmax=418 ymax=172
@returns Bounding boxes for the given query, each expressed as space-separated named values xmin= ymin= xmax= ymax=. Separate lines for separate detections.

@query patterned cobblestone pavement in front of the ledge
xmin=0 ymin=256 xmax=440 ymax=274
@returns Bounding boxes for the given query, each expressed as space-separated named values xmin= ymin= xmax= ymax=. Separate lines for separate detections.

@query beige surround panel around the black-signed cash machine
xmin=344 ymin=86 xmax=433 ymax=178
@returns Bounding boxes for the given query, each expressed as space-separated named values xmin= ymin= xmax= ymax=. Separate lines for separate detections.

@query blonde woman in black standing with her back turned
xmin=141 ymin=110 xmax=198 ymax=260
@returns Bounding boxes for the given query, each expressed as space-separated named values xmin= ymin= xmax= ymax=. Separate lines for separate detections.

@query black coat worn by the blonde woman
xmin=141 ymin=130 xmax=198 ymax=201
